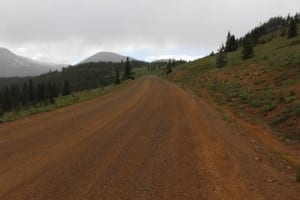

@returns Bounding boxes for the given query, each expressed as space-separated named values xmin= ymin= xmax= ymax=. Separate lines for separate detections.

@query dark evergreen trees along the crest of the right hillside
xmin=216 ymin=13 xmax=300 ymax=67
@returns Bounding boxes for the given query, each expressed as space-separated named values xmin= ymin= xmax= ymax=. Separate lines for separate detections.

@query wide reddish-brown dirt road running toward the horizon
xmin=0 ymin=76 xmax=300 ymax=200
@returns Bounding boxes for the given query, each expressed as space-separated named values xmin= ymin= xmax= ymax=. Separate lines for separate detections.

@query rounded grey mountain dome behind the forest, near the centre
xmin=80 ymin=52 xmax=135 ymax=63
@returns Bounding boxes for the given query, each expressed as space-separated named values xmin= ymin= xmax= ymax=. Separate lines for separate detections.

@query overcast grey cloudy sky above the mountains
xmin=0 ymin=0 xmax=300 ymax=64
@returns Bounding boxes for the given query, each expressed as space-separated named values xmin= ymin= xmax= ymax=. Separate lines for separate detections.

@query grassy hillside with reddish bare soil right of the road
xmin=169 ymin=26 xmax=300 ymax=141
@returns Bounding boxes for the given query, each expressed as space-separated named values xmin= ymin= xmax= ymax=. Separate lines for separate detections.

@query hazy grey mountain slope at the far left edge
xmin=0 ymin=48 xmax=62 ymax=77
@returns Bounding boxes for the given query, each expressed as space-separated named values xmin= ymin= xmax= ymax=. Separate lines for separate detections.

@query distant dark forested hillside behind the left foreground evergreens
xmin=0 ymin=61 xmax=148 ymax=91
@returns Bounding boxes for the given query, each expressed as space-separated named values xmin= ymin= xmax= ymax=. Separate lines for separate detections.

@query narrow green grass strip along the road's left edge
xmin=0 ymin=81 xmax=128 ymax=122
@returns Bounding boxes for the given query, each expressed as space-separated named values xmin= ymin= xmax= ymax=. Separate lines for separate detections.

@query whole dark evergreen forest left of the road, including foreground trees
xmin=0 ymin=58 xmax=141 ymax=116
